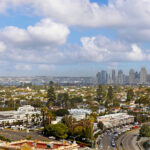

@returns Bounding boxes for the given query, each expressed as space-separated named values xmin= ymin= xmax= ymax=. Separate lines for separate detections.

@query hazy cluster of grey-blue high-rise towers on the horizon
xmin=96 ymin=67 xmax=150 ymax=85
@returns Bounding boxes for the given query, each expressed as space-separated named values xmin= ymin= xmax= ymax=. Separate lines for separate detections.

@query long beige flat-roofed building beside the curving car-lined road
xmin=97 ymin=113 xmax=134 ymax=129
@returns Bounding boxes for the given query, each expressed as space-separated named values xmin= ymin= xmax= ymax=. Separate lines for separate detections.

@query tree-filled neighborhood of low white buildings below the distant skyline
xmin=0 ymin=81 xmax=150 ymax=149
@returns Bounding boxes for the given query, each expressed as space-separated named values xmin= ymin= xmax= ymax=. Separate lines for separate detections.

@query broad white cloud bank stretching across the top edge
xmin=0 ymin=0 xmax=150 ymax=27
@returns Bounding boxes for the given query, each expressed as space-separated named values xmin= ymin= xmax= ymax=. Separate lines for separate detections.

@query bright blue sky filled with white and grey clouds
xmin=0 ymin=0 xmax=150 ymax=76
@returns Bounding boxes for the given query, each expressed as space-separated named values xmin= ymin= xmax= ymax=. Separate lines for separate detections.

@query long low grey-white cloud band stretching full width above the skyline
xmin=0 ymin=36 xmax=150 ymax=66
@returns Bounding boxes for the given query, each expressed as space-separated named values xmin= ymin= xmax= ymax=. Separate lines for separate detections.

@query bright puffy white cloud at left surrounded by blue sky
xmin=0 ymin=19 xmax=70 ymax=49
